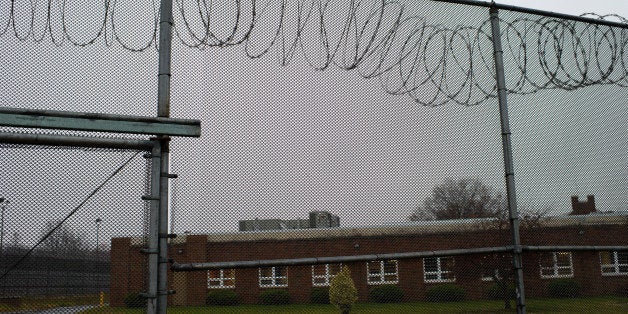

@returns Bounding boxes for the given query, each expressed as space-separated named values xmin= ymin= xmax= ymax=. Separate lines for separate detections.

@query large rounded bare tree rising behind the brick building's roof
xmin=409 ymin=178 xmax=506 ymax=221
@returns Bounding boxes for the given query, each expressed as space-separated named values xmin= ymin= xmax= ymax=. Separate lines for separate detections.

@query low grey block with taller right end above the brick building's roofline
xmin=238 ymin=211 xmax=340 ymax=231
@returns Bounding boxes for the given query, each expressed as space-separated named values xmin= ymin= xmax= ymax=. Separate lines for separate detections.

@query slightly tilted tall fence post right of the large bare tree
xmin=489 ymin=6 xmax=526 ymax=313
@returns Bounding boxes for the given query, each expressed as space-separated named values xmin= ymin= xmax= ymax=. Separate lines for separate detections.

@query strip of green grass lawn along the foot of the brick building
xmin=83 ymin=297 xmax=628 ymax=314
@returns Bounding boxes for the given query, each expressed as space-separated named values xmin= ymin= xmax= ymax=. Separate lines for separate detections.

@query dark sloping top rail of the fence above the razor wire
xmin=432 ymin=0 xmax=628 ymax=29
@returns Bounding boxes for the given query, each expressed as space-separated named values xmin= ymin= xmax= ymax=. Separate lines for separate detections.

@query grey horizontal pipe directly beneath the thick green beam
xmin=0 ymin=132 xmax=156 ymax=150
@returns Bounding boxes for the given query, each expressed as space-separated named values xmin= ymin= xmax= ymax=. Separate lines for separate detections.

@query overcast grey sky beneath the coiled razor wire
xmin=0 ymin=0 xmax=628 ymax=244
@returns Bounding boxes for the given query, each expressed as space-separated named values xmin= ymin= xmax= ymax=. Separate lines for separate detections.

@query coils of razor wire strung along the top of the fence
xmin=0 ymin=0 xmax=628 ymax=106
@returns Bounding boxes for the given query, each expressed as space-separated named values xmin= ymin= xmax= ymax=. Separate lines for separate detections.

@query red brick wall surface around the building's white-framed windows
xmin=111 ymin=224 xmax=628 ymax=306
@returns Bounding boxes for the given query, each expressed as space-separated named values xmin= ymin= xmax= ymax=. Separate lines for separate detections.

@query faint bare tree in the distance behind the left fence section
xmin=41 ymin=221 xmax=87 ymax=257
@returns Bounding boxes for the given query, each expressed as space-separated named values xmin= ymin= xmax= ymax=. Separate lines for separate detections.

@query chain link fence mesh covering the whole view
xmin=0 ymin=1 xmax=628 ymax=313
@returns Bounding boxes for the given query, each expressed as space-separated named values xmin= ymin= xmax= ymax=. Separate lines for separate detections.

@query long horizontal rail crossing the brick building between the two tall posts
xmin=171 ymin=246 xmax=512 ymax=271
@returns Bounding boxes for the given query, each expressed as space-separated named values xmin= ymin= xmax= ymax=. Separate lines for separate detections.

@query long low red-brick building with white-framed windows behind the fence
xmin=111 ymin=213 xmax=628 ymax=306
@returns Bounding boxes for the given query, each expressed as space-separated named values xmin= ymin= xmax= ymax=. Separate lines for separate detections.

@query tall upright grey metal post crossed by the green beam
xmin=157 ymin=0 xmax=172 ymax=314
